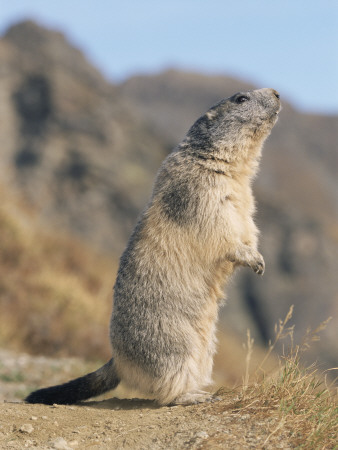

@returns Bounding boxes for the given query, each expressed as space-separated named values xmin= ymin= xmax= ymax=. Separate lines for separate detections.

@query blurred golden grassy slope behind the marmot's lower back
xmin=0 ymin=188 xmax=116 ymax=359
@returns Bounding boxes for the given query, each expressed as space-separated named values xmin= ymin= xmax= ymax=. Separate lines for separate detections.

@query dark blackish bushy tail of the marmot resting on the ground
xmin=25 ymin=358 xmax=120 ymax=405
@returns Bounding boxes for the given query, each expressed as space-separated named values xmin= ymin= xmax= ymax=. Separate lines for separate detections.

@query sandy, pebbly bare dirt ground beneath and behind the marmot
xmin=0 ymin=350 xmax=292 ymax=449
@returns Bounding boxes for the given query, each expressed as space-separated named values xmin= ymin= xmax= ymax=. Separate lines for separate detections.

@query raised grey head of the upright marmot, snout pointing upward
xmin=187 ymin=88 xmax=281 ymax=162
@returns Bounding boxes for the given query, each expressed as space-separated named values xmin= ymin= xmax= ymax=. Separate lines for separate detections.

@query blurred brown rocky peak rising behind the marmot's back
xmin=0 ymin=22 xmax=165 ymax=251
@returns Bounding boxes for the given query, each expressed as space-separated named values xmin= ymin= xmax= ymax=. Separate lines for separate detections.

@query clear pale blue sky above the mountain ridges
xmin=0 ymin=0 xmax=338 ymax=114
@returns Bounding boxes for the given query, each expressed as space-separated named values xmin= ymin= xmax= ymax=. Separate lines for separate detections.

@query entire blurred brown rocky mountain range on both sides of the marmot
xmin=0 ymin=22 xmax=338 ymax=366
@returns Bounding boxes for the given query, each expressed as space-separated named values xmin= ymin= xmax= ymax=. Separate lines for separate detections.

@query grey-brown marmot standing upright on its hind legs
xmin=26 ymin=88 xmax=280 ymax=405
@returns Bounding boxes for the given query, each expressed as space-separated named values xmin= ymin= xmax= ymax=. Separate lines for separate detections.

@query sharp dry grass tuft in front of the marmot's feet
xmin=217 ymin=308 xmax=338 ymax=449
